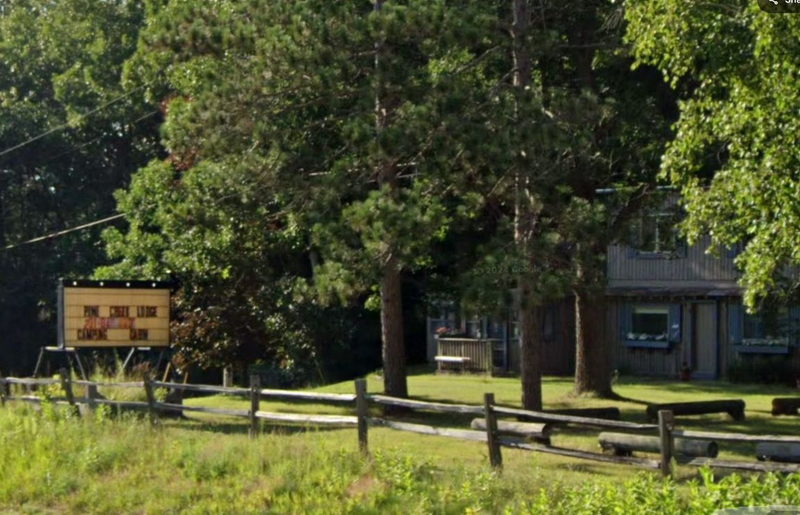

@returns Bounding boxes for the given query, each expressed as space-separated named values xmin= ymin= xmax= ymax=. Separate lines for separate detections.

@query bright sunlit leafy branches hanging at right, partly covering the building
xmin=626 ymin=0 xmax=800 ymax=308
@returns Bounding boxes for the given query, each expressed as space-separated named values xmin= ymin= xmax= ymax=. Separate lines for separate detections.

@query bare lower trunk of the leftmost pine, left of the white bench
xmin=381 ymin=259 xmax=408 ymax=397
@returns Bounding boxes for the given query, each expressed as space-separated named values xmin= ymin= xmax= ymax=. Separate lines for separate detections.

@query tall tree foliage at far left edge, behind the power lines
xmin=0 ymin=0 xmax=159 ymax=373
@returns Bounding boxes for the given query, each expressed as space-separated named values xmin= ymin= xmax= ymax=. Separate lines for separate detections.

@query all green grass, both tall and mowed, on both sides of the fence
xmin=0 ymin=370 xmax=800 ymax=515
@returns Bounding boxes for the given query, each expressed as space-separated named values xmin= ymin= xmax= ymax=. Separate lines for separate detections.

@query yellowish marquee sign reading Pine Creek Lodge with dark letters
xmin=58 ymin=279 xmax=171 ymax=347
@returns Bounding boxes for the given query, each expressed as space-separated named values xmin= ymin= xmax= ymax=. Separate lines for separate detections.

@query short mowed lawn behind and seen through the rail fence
xmin=186 ymin=371 xmax=800 ymax=482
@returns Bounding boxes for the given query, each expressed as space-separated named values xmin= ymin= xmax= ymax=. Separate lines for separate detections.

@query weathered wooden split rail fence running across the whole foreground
xmin=0 ymin=372 xmax=800 ymax=476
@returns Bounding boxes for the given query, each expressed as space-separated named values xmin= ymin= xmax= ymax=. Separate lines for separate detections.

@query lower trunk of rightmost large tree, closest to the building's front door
xmin=575 ymin=289 xmax=614 ymax=397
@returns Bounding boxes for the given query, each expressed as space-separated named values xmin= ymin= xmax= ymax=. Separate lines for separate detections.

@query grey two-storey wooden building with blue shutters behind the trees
xmin=428 ymin=231 xmax=800 ymax=379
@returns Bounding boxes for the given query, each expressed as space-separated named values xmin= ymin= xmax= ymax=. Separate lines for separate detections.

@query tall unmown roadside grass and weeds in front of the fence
xmin=0 ymin=403 xmax=800 ymax=514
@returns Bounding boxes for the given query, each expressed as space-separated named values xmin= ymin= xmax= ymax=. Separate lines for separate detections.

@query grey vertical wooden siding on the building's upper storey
xmin=607 ymin=238 xmax=739 ymax=288
